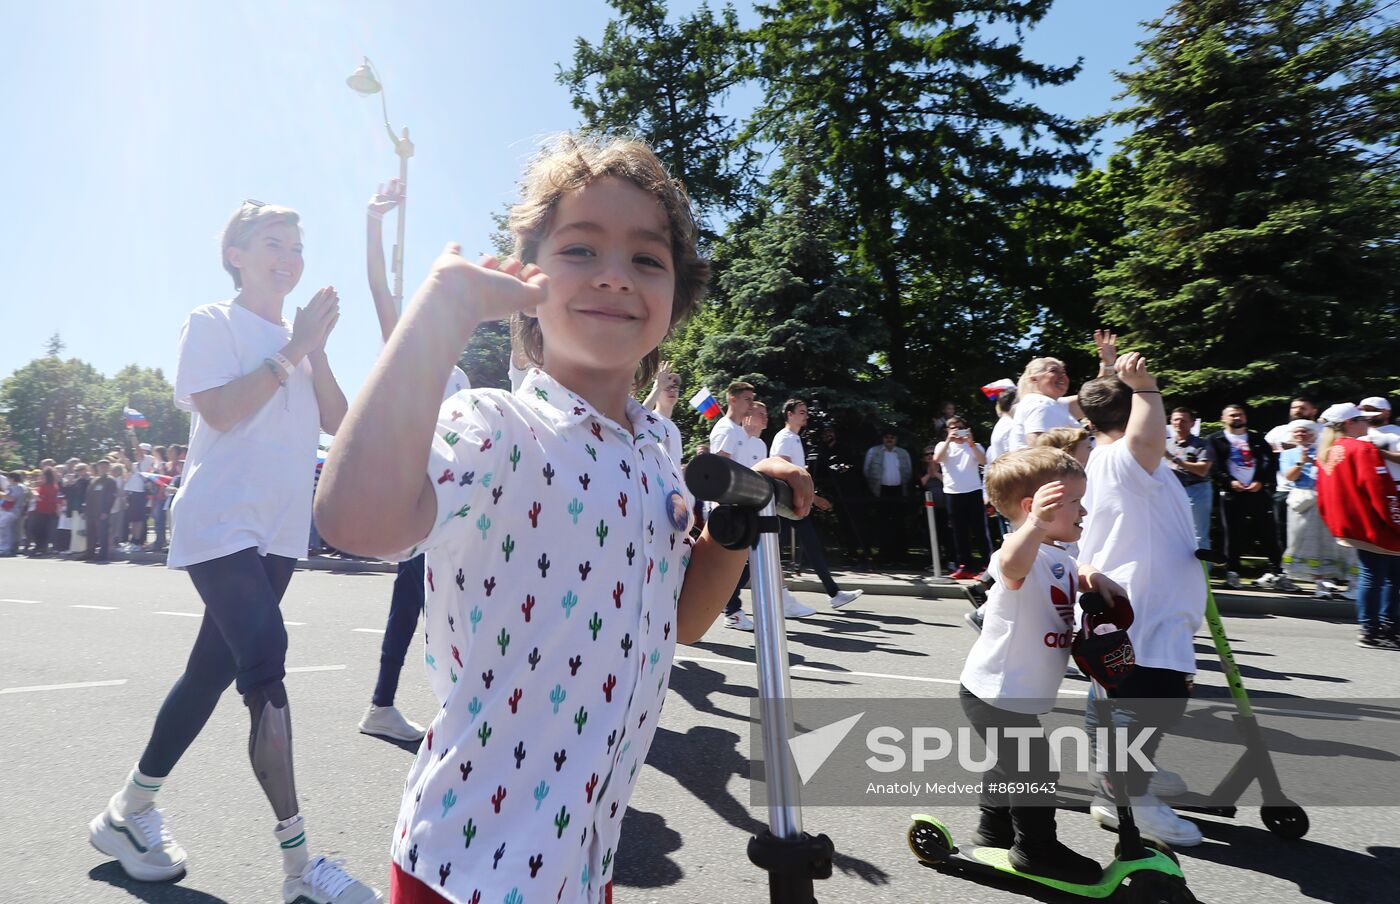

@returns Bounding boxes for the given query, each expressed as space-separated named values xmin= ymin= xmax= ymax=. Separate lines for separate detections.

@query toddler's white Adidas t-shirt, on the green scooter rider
xmin=958 ymin=543 xmax=1079 ymax=714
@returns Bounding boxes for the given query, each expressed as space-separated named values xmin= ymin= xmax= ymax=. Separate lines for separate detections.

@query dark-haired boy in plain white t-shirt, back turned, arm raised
xmin=1079 ymin=351 xmax=1205 ymax=847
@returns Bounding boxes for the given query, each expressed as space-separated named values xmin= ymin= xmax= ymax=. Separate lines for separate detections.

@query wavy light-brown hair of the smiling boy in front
xmin=507 ymin=133 xmax=710 ymax=386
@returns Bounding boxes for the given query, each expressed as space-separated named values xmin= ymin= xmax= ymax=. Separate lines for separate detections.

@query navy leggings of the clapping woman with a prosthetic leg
xmin=139 ymin=549 xmax=297 ymax=777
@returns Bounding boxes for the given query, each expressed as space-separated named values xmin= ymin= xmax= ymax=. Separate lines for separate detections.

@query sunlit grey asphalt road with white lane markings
xmin=0 ymin=558 xmax=1400 ymax=904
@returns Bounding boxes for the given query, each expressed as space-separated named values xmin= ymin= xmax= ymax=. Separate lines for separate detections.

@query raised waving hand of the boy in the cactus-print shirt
xmin=419 ymin=242 xmax=549 ymax=323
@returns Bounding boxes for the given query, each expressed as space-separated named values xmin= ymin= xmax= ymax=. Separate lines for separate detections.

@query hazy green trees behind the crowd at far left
xmin=0 ymin=355 xmax=189 ymax=465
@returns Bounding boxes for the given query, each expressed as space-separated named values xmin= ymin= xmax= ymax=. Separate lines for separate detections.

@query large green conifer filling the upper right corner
xmin=1098 ymin=0 xmax=1400 ymax=410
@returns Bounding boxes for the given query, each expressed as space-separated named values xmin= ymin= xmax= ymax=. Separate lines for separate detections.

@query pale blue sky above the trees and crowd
xmin=0 ymin=0 xmax=1168 ymax=414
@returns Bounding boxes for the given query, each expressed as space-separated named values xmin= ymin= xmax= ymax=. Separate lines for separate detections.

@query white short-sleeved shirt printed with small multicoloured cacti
xmin=392 ymin=369 xmax=693 ymax=904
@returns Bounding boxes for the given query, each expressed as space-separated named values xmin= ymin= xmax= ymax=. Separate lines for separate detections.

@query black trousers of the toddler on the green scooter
xmin=958 ymin=687 xmax=1060 ymax=844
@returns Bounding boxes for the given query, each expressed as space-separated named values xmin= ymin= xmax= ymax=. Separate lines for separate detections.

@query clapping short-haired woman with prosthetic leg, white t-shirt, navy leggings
xmin=88 ymin=202 xmax=379 ymax=904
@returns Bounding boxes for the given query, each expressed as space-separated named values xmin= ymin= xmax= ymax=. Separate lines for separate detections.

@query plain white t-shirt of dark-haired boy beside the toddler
xmin=1079 ymin=439 xmax=1205 ymax=672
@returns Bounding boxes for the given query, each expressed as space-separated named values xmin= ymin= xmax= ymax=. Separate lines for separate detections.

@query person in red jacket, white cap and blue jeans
xmin=1317 ymin=402 xmax=1400 ymax=648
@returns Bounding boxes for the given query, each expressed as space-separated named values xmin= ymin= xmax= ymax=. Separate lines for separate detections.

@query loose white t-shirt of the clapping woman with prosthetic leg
xmin=167 ymin=301 xmax=321 ymax=568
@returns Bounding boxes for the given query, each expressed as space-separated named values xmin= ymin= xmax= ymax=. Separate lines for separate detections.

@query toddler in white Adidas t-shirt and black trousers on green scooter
xmin=959 ymin=448 xmax=1127 ymax=884
